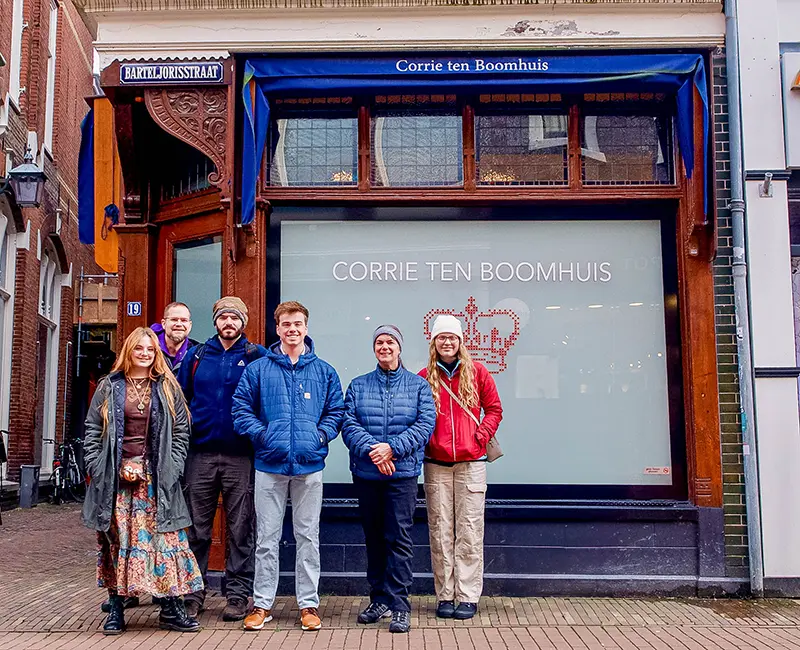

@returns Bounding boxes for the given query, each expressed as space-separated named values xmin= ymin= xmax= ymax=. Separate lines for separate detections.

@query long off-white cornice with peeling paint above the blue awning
xmin=92 ymin=5 xmax=725 ymax=68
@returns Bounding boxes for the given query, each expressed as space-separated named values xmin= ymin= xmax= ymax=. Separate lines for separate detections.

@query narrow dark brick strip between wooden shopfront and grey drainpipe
xmin=712 ymin=50 xmax=748 ymax=577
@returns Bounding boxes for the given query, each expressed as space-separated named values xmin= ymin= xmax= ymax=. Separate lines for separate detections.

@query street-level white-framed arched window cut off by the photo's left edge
xmin=0 ymin=213 xmax=17 ymax=478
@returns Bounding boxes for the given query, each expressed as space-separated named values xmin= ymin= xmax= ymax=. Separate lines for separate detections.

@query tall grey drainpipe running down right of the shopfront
xmin=725 ymin=0 xmax=764 ymax=597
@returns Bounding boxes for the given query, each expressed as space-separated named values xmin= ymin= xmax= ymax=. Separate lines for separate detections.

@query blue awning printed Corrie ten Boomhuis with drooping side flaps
xmin=242 ymin=53 xmax=709 ymax=224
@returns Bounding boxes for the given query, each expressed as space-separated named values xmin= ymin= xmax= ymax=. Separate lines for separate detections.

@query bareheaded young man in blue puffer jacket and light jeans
xmin=233 ymin=301 xmax=344 ymax=630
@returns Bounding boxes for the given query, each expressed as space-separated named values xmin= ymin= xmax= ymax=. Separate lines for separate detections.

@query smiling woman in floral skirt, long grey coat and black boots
xmin=83 ymin=327 xmax=203 ymax=634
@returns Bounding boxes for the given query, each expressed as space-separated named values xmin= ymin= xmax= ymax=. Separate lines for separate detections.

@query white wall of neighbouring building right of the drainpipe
xmin=739 ymin=0 xmax=800 ymax=578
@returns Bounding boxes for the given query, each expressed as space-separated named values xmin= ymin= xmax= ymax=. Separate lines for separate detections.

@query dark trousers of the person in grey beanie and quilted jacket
xmin=353 ymin=476 xmax=417 ymax=612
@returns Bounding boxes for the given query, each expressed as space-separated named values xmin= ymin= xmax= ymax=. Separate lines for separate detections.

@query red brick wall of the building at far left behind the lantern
xmin=0 ymin=0 xmax=108 ymax=478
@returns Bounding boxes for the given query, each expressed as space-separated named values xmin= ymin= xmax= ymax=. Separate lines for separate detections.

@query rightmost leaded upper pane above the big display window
xmin=581 ymin=113 xmax=674 ymax=185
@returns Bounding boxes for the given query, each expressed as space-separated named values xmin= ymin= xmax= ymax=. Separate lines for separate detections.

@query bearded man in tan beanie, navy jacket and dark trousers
xmin=178 ymin=296 xmax=267 ymax=621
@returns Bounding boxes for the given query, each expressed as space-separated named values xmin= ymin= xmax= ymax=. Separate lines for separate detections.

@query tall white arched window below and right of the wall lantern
xmin=36 ymin=248 xmax=61 ymax=474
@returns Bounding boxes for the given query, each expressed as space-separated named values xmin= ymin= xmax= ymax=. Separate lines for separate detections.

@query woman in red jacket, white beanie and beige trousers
xmin=419 ymin=315 xmax=503 ymax=619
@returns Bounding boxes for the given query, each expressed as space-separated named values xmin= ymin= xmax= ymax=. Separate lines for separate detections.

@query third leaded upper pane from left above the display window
xmin=475 ymin=114 xmax=567 ymax=185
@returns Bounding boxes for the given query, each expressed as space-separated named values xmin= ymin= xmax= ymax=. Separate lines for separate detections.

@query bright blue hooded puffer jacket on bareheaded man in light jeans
xmin=233 ymin=337 xmax=344 ymax=476
